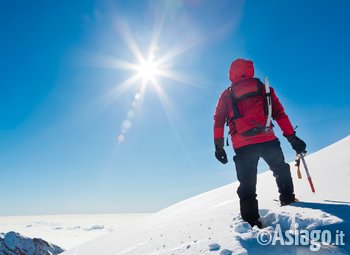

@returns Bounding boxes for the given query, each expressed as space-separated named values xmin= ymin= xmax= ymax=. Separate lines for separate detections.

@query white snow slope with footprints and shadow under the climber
xmin=63 ymin=136 xmax=350 ymax=255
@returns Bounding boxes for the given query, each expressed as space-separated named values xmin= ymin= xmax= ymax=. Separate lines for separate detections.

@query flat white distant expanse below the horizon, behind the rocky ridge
xmin=0 ymin=214 xmax=149 ymax=249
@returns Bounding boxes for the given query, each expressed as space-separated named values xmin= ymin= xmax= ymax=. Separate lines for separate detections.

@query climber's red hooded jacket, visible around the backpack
xmin=214 ymin=59 xmax=294 ymax=149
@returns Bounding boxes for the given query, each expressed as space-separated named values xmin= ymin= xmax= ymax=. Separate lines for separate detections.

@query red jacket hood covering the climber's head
xmin=229 ymin=58 xmax=254 ymax=84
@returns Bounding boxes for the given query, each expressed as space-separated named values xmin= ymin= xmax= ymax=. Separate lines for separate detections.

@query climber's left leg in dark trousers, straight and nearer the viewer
xmin=233 ymin=145 xmax=260 ymax=226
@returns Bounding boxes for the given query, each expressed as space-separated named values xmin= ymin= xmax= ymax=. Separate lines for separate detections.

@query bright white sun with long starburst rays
xmin=96 ymin=18 xmax=206 ymax=144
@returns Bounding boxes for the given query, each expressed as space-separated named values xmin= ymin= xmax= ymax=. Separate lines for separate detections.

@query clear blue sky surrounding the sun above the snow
xmin=0 ymin=0 xmax=350 ymax=215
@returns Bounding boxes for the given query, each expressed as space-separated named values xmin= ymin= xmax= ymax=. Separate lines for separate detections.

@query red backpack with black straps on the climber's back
xmin=227 ymin=78 xmax=270 ymax=137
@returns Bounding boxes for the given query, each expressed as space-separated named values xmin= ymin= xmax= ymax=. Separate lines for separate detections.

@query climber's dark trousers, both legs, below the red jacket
xmin=233 ymin=139 xmax=294 ymax=223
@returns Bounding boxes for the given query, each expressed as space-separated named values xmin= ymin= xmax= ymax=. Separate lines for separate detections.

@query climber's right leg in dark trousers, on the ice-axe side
xmin=261 ymin=140 xmax=295 ymax=204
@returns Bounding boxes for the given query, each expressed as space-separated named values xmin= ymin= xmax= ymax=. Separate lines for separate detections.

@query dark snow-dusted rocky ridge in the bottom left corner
xmin=0 ymin=231 xmax=64 ymax=255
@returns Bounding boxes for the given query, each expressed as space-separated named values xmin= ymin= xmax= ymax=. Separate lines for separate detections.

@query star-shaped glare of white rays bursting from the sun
xmin=90 ymin=5 xmax=228 ymax=144
